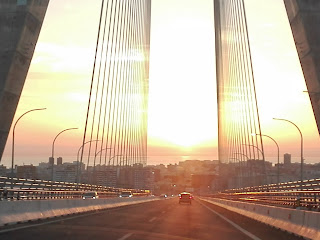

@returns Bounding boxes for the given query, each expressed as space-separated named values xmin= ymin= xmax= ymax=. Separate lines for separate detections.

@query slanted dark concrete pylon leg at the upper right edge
xmin=284 ymin=0 xmax=320 ymax=133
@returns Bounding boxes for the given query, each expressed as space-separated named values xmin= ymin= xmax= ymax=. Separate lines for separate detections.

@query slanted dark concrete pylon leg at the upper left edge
xmin=0 ymin=0 xmax=49 ymax=161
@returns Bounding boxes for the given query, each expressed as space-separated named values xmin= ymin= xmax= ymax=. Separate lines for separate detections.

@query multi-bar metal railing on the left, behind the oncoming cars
xmin=0 ymin=177 xmax=149 ymax=201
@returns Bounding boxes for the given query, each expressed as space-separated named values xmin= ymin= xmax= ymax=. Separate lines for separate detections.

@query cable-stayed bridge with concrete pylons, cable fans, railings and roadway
xmin=0 ymin=0 xmax=320 ymax=239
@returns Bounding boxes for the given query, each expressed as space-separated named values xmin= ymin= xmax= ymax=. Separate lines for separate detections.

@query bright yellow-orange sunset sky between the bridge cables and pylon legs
xmin=1 ymin=0 xmax=320 ymax=165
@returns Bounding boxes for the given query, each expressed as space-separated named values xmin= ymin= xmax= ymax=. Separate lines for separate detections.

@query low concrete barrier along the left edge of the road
xmin=0 ymin=197 xmax=160 ymax=226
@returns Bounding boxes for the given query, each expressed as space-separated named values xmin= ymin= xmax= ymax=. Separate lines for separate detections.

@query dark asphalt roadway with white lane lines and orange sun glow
xmin=0 ymin=198 xmax=301 ymax=240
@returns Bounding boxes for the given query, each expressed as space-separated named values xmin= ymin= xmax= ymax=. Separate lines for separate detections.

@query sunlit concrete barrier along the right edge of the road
xmin=200 ymin=198 xmax=320 ymax=239
